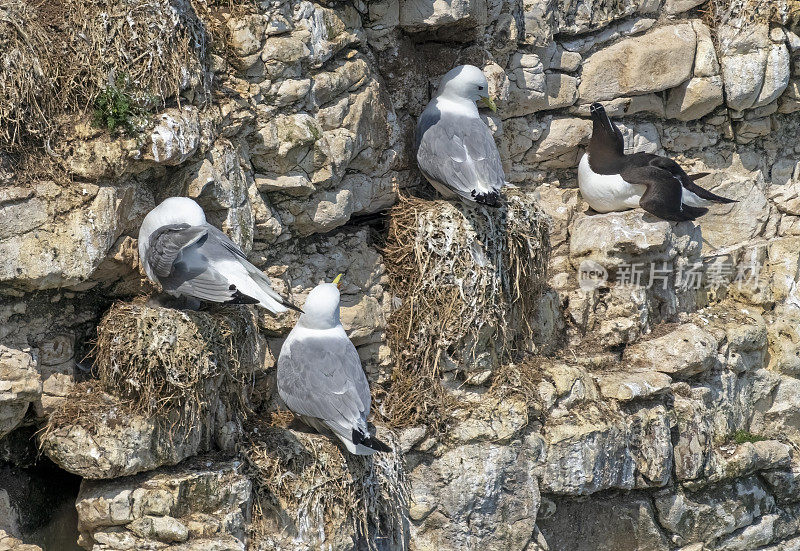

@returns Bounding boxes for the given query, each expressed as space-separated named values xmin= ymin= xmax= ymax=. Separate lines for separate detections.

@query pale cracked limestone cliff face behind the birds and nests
xmin=0 ymin=0 xmax=800 ymax=551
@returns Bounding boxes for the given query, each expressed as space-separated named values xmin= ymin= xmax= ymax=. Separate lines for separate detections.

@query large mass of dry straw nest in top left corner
xmin=0 ymin=0 xmax=210 ymax=149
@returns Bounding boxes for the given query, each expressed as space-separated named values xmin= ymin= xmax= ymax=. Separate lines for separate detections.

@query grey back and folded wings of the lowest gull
xmin=278 ymin=337 xmax=370 ymax=438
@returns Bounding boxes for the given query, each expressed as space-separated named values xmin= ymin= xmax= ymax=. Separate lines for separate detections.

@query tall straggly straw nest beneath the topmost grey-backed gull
xmin=382 ymin=190 xmax=550 ymax=429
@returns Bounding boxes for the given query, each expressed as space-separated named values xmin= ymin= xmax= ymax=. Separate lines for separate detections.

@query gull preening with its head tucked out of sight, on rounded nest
xmin=139 ymin=197 xmax=298 ymax=314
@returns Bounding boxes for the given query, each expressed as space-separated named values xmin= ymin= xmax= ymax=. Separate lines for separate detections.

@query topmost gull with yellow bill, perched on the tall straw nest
xmin=414 ymin=65 xmax=506 ymax=207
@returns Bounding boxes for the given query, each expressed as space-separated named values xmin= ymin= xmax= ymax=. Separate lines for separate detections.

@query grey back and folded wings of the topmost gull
xmin=417 ymin=113 xmax=505 ymax=200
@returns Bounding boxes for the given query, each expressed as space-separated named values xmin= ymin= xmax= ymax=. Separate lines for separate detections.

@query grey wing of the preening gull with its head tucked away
xmin=146 ymin=224 xmax=239 ymax=302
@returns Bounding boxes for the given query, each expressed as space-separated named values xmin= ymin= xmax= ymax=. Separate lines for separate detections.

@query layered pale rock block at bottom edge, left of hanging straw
xmin=75 ymin=457 xmax=253 ymax=551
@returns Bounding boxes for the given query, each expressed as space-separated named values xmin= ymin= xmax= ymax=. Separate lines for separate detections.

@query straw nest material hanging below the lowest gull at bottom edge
xmin=243 ymin=422 xmax=408 ymax=551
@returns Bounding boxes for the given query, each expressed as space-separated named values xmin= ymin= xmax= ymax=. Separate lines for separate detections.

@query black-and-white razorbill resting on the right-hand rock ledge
xmin=578 ymin=103 xmax=736 ymax=222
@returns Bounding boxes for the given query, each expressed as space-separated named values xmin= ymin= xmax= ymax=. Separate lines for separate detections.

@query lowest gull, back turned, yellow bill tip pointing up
xmin=278 ymin=274 xmax=391 ymax=455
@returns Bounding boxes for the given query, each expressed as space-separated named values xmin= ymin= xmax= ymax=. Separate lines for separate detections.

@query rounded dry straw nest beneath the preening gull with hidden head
xmin=94 ymin=303 xmax=263 ymax=424
